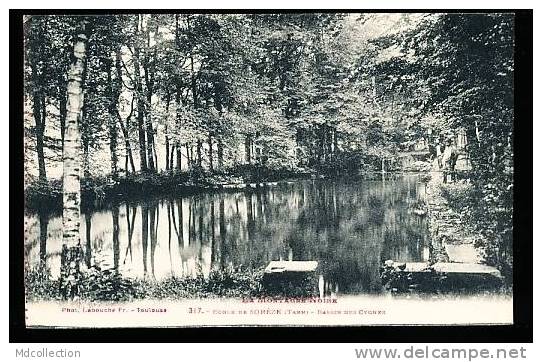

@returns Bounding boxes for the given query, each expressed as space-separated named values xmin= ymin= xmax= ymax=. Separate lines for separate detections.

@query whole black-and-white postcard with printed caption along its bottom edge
xmin=21 ymin=11 xmax=515 ymax=328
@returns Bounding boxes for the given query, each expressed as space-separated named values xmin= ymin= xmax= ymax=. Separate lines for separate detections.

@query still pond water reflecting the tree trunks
xmin=25 ymin=175 xmax=428 ymax=294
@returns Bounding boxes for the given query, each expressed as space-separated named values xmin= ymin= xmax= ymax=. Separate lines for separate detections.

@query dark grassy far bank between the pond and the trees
xmin=24 ymin=170 xmax=427 ymax=215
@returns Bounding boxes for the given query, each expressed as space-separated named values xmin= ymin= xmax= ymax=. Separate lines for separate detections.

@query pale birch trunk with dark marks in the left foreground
xmin=60 ymin=20 xmax=87 ymax=298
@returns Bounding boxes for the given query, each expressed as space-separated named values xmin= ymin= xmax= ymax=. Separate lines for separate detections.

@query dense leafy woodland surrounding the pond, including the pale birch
xmin=23 ymin=13 xmax=514 ymax=298
